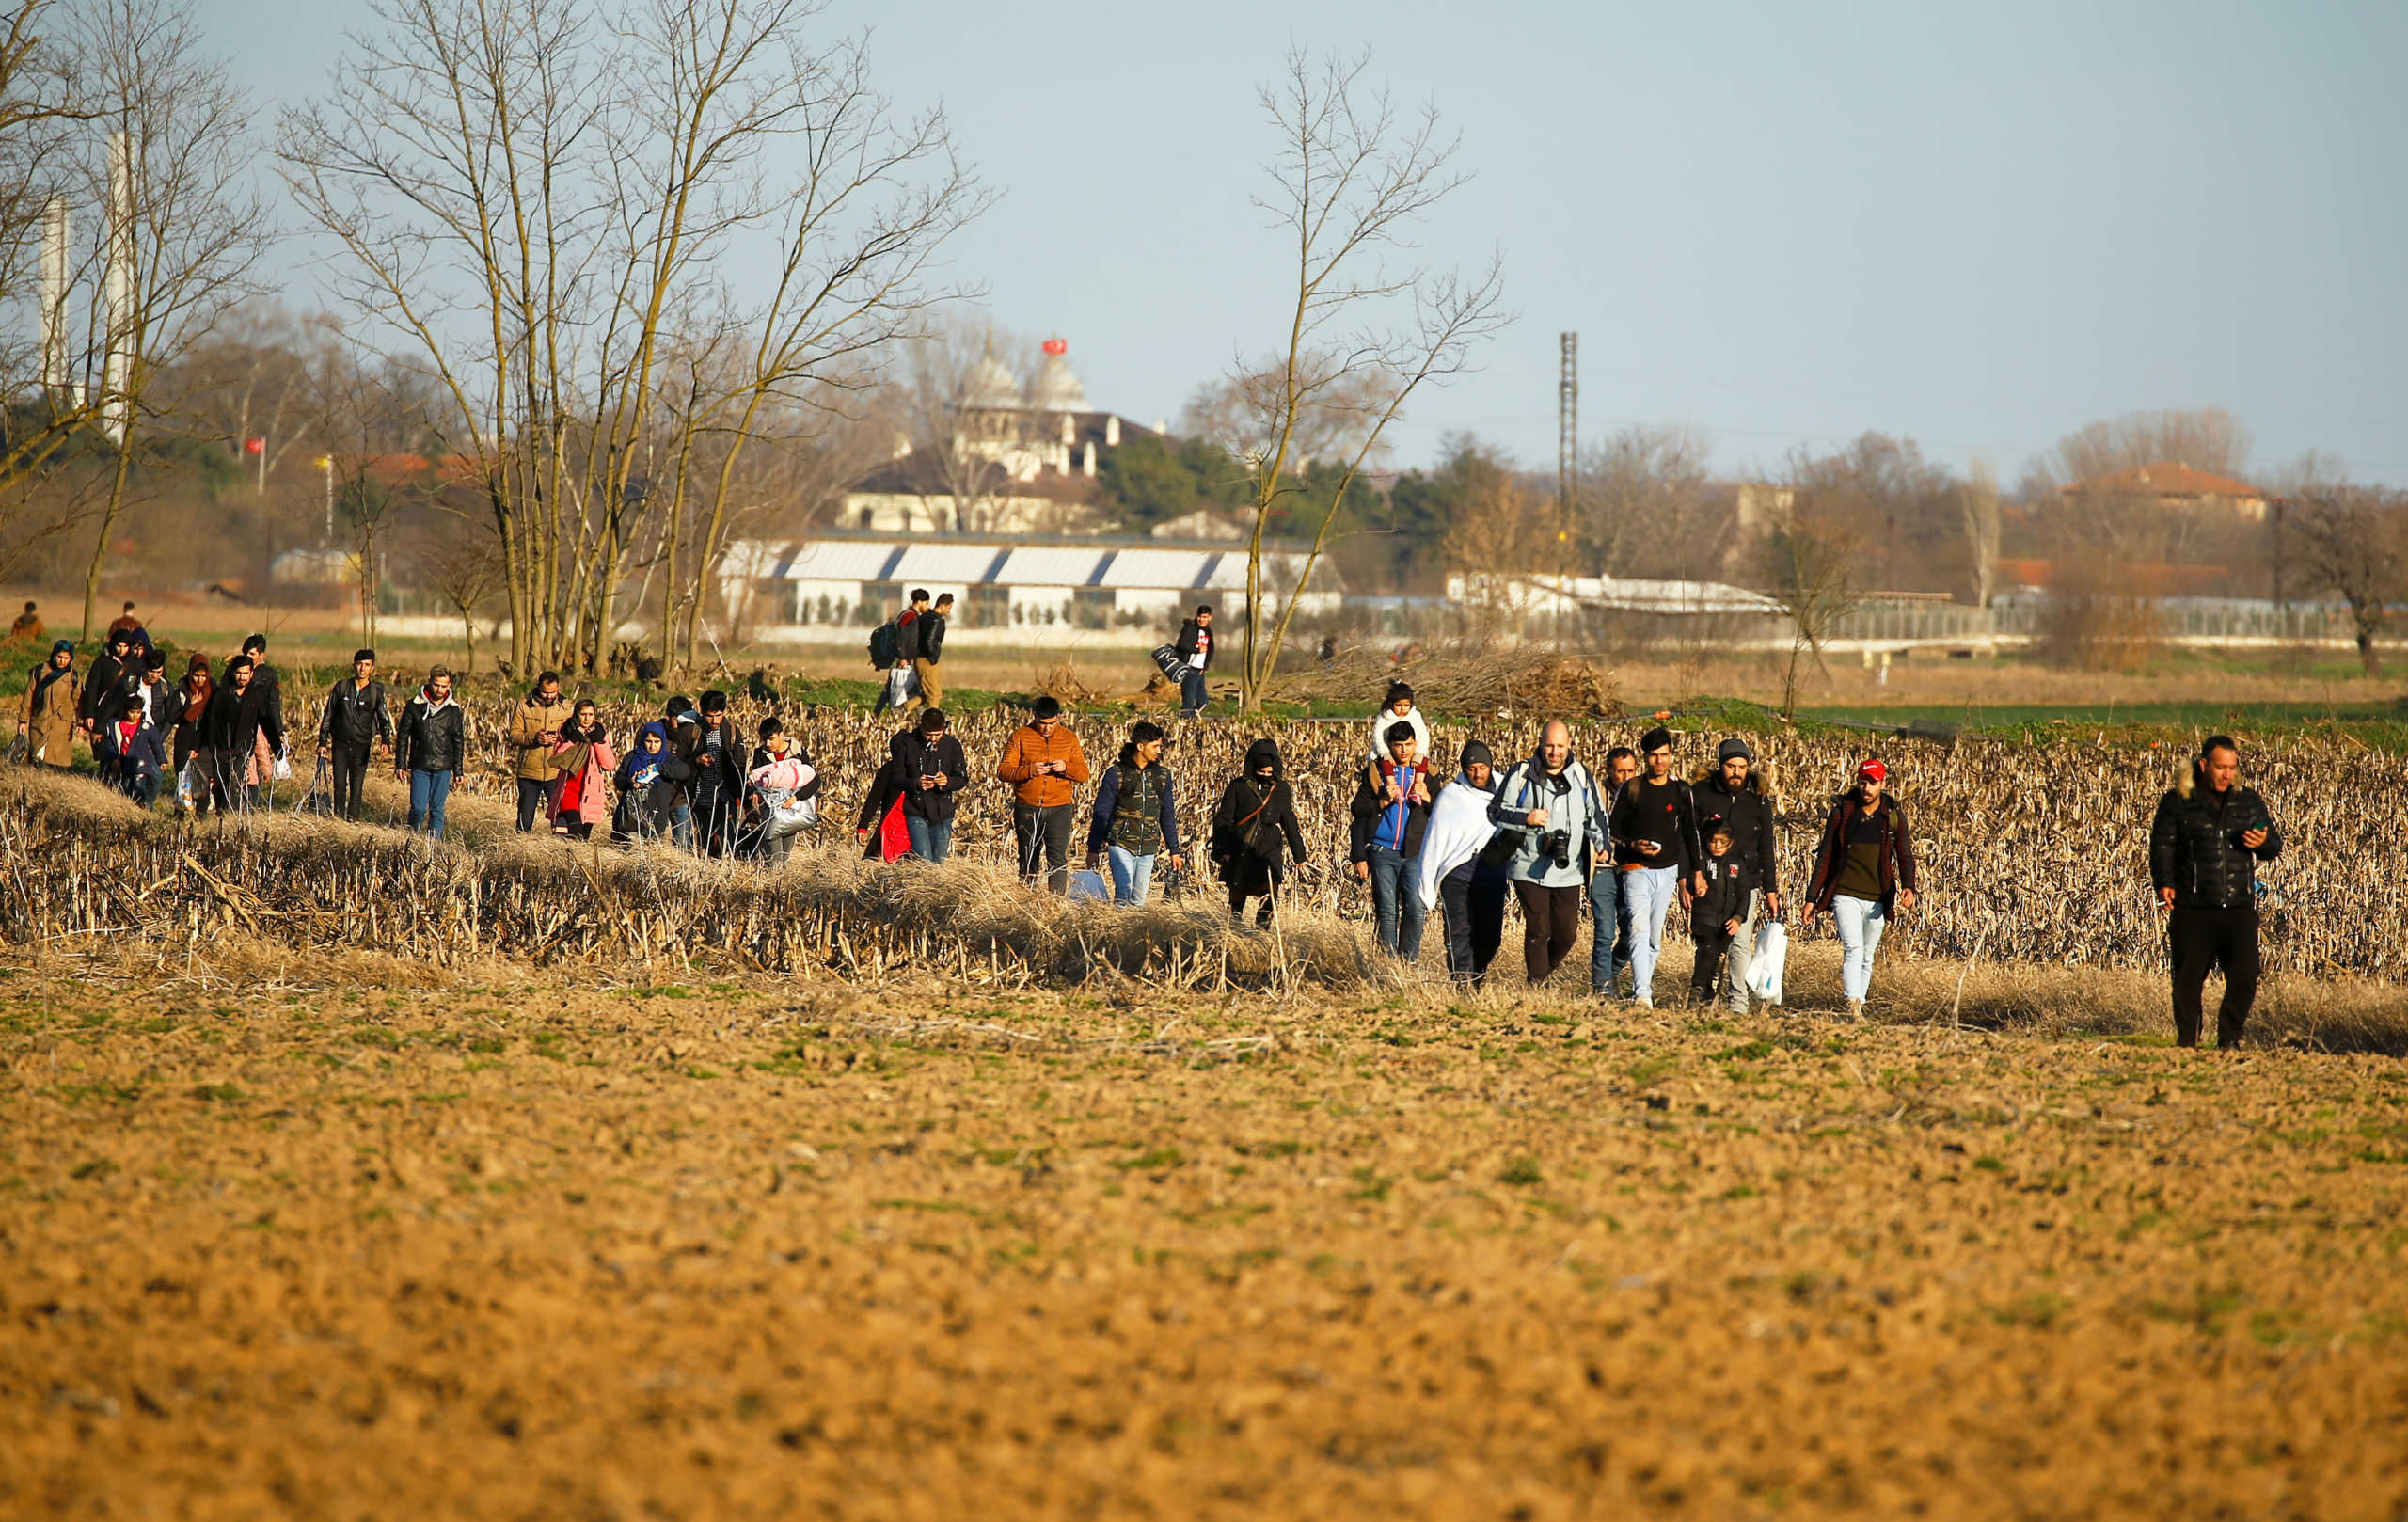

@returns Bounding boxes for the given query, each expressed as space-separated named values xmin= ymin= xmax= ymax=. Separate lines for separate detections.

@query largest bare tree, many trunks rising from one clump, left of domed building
xmin=279 ymin=0 xmax=980 ymax=667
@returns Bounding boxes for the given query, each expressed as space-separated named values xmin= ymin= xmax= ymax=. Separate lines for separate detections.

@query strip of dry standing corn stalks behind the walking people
xmin=0 ymin=706 xmax=2408 ymax=985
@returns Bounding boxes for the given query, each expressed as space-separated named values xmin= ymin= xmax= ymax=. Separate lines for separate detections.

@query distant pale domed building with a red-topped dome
xmin=838 ymin=337 xmax=1158 ymax=534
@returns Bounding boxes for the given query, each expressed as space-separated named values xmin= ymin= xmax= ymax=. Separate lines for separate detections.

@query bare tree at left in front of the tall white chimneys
xmin=72 ymin=0 xmax=272 ymax=638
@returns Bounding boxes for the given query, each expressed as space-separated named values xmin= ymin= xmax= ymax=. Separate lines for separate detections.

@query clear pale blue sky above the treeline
xmin=216 ymin=0 xmax=2408 ymax=484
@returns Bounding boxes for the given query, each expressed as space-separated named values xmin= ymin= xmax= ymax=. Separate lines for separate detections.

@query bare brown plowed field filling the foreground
xmin=0 ymin=956 xmax=2408 ymax=1519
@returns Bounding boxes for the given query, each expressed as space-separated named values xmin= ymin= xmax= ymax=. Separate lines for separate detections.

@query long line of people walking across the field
xmin=17 ymin=616 xmax=2283 ymax=1045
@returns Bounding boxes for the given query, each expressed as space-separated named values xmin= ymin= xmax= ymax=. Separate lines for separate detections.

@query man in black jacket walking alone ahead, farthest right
xmin=2148 ymin=735 xmax=2283 ymax=1050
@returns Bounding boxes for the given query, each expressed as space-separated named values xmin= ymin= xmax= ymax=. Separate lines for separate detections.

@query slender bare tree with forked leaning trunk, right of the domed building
xmin=1235 ymin=48 xmax=1510 ymax=713
